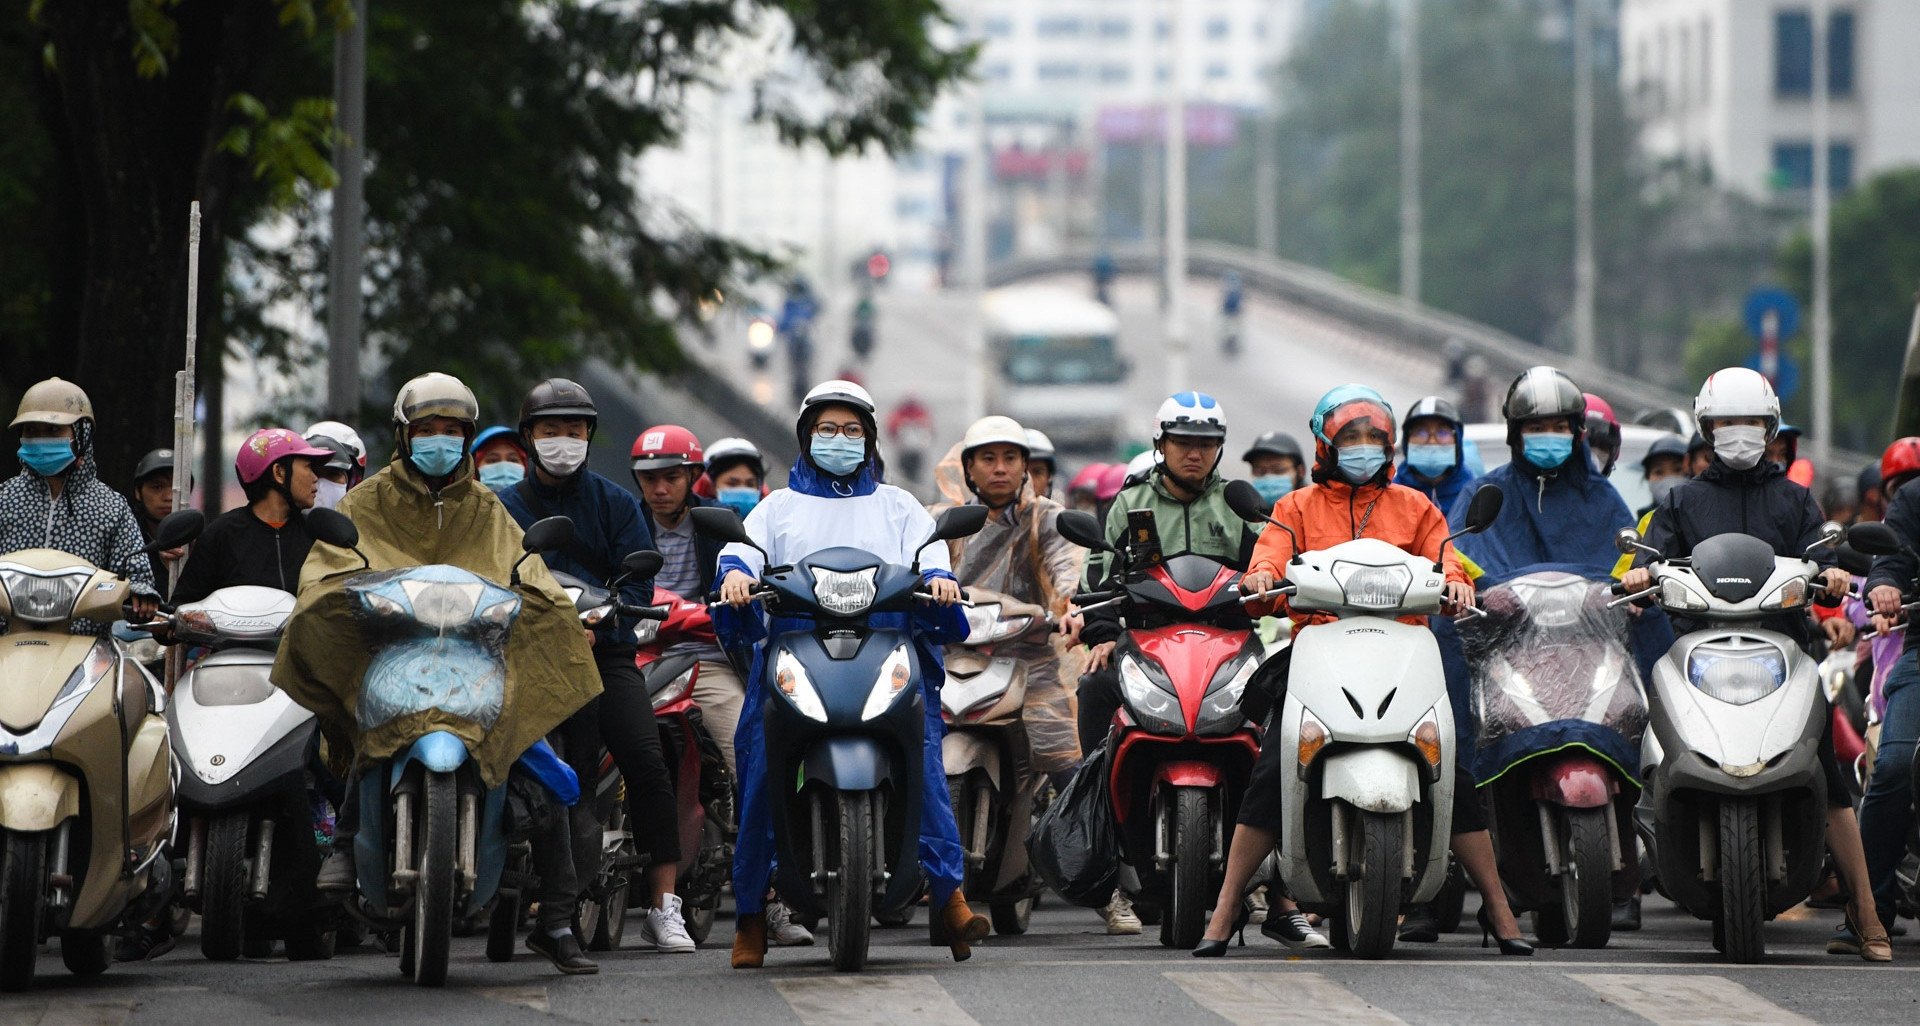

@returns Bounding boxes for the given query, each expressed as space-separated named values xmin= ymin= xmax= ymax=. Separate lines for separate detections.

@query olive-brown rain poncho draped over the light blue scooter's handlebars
xmin=273 ymin=455 xmax=601 ymax=788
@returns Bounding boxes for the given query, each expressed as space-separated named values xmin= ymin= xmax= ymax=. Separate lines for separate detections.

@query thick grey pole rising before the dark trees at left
xmin=326 ymin=0 xmax=367 ymax=425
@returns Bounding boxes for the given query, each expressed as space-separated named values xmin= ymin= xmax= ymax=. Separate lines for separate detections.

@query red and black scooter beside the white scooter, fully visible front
xmin=1060 ymin=511 xmax=1263 ymax=949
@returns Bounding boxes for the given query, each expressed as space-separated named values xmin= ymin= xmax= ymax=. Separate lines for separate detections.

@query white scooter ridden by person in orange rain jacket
xmin=1227 ymin=482 xmax=1503 ymax=959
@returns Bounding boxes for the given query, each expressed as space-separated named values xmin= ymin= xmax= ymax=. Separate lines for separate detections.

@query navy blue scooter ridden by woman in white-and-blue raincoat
xmin=691 ymin=505 xmax=987 ymax=970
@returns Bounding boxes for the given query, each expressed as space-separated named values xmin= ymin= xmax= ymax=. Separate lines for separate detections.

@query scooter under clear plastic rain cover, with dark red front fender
xmin=1461 ymin=571 xmax=1647 ymax=947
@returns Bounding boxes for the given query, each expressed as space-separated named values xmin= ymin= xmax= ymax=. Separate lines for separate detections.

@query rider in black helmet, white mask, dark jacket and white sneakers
xmin=495 ymin=379 xmax=695 ymax=955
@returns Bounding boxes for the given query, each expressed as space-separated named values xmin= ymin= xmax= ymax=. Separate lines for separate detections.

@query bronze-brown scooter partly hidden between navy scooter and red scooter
xmin=941 ymin=588 xmax=1054 ymax=936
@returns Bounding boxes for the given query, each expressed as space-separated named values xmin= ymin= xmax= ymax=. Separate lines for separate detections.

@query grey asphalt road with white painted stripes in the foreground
xmin=11 ymin=897 xmax=1920 ymax=1026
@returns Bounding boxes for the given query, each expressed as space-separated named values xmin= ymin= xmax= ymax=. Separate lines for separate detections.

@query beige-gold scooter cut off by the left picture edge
xmin=0 ymin=509 xmax=205 ymax=991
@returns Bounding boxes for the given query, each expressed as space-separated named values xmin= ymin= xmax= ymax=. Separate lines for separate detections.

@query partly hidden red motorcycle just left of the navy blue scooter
xmin=630 ymin=588 xmax=745 ymax=943
